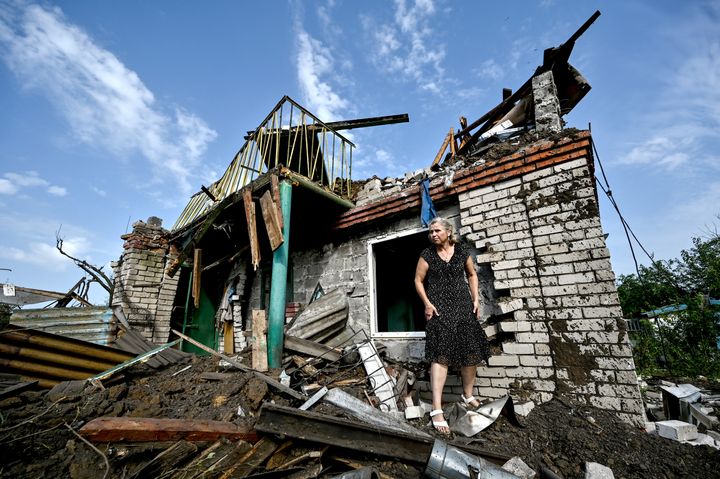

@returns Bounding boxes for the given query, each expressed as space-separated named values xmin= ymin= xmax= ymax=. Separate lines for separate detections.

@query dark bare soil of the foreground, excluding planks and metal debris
xmin=0 ymin=357 xmax=720 ymax=479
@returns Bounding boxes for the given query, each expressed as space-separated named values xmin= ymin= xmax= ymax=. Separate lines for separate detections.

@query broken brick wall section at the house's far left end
xmin=112 ymin=217 xmax=180 ymax=344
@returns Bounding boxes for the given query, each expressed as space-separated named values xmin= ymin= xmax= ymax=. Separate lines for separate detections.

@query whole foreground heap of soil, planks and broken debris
xmin=0 ymin=346 xmax=720 ymax=479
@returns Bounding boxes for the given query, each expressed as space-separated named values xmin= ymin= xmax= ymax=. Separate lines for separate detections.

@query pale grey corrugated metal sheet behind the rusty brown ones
xmin=10 ymin=307 xmax=117 ymax=346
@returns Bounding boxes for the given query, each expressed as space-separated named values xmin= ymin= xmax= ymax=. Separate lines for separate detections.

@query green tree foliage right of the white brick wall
xmin=618 ymin=234 xmax=720 ymax=377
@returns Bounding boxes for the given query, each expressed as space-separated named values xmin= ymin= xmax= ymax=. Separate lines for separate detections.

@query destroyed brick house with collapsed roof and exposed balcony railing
xmin=114 ymin=12 xmax=643 ymax=424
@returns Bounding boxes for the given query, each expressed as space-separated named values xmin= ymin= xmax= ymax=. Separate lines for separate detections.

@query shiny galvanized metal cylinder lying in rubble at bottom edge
xmin=425 ymin=439 xmax=518 ymax=479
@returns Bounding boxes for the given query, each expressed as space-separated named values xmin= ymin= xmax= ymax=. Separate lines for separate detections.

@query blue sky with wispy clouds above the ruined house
xmin=0 ymin=0 xmax=720 ymax=302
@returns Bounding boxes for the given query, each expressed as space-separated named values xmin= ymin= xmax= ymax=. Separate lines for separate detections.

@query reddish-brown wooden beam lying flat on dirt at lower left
xmin=80 ymin=417 xmax=258 ymax=442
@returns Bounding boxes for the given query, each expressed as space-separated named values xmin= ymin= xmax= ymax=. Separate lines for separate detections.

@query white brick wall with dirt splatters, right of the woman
xmin=459 ymin=158 xmax=643 ymax=424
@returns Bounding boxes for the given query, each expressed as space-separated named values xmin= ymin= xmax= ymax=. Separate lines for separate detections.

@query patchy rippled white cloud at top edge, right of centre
xmin=362 ymin=0 xmax=445 ymax=93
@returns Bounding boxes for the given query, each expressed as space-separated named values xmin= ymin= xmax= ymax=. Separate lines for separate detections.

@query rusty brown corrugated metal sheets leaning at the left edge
xmin=0 ymin=325 xmax=135 ymax=388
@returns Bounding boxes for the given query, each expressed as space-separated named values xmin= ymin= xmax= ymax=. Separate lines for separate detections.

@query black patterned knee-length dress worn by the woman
xmin=421 ymin=243 xmax=490 ymax=368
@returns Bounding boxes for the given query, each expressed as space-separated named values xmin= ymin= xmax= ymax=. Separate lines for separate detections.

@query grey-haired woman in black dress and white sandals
xmin=415 ymin=217 xmax=490 ymax=434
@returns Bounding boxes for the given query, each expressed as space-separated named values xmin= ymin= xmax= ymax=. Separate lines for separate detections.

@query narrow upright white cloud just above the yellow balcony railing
xmin=296 ymin=25 xmax=349 ymax=121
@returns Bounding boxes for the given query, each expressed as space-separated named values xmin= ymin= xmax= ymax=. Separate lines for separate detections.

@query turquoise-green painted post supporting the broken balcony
xmin=268 ymin=180 xmax=292 ymax=368
